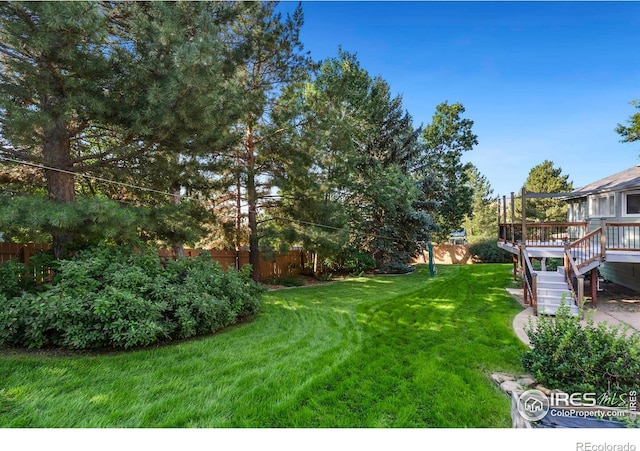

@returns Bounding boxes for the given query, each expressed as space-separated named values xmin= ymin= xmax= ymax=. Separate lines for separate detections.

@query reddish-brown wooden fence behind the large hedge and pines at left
xmin=0 ymin=242 xmax=309 ymax=280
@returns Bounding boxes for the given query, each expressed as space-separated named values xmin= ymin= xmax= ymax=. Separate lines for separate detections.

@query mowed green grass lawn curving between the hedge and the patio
xmin=0 ymin=265 xmax=525 ymax=428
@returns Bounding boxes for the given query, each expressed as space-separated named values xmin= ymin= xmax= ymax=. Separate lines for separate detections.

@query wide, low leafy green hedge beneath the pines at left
xmin=0 ymin=247 xmax=263 ymax=349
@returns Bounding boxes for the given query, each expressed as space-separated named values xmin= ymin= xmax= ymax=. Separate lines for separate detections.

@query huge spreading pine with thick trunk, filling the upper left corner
xmin=0 ymin=2 xmax=245 ymax=256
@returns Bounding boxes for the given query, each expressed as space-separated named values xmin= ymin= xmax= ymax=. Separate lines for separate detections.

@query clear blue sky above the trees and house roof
xmin=280 ymin=1 xmax=640 ymax=196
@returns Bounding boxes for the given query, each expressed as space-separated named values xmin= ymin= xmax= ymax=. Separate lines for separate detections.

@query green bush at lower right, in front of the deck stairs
xmin=522 ymin=306 xmax=640 ymax=400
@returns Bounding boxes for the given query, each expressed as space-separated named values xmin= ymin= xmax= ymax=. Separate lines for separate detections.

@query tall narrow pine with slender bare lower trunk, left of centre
xmin=233 ymin=2 xmax=312 ymax=280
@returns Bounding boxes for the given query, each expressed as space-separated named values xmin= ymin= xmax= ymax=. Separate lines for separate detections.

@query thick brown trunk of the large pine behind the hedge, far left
xmin=42 ymin=118 xmax=76 ymax=259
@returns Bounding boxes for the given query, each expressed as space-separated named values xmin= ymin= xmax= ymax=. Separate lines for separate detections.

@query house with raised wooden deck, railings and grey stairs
xmin=498 ymin=166 xmax=640 ymax=314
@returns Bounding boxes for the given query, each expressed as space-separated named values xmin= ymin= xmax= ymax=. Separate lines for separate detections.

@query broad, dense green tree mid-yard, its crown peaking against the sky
xmin=285 ymin=51 xmax=428 ymax=266
